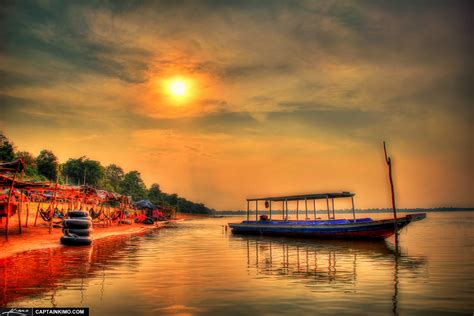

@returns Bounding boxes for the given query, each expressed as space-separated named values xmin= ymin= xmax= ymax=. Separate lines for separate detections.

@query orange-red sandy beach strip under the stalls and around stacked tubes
xmin=0 ymin=214 xmax=201 ymax=260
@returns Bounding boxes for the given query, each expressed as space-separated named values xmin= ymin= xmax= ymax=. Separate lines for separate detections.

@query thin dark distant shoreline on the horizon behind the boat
xmin=214 ymin=207 xmax=474 ymax=215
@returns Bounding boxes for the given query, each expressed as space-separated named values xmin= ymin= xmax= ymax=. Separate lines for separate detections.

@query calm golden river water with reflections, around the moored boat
xmin=0 ymin=212 xmax=474 ymax=315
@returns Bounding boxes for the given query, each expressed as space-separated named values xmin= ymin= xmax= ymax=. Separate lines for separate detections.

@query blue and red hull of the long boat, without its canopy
xmin=229 ymin=213 xmax=426 ymax=240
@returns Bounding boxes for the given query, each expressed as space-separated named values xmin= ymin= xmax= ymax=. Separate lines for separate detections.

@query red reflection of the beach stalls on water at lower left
xmin=0 ymin=231 xmax=150 ymax=306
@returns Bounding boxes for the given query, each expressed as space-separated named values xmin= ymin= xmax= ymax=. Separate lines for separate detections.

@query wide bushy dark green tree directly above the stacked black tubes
xmin=62 ymin=156 xmax=104 ymax=187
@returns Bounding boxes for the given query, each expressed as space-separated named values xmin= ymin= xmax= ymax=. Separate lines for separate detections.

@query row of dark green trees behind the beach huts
xmin=0 ymin=133 xmax=213 ymax=214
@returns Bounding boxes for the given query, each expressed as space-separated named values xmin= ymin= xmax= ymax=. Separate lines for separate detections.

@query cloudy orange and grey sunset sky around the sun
xmin=0 ymin=0 xmax=474 ymax=210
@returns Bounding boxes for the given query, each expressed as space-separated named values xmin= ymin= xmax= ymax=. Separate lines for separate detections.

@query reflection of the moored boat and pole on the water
xmin=232 ymin=236 xmax=427 ymax=315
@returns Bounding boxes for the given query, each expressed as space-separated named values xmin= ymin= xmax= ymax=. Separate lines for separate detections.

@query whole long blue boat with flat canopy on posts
xmin=229 ymin=192 xmax=426 ymax=240
